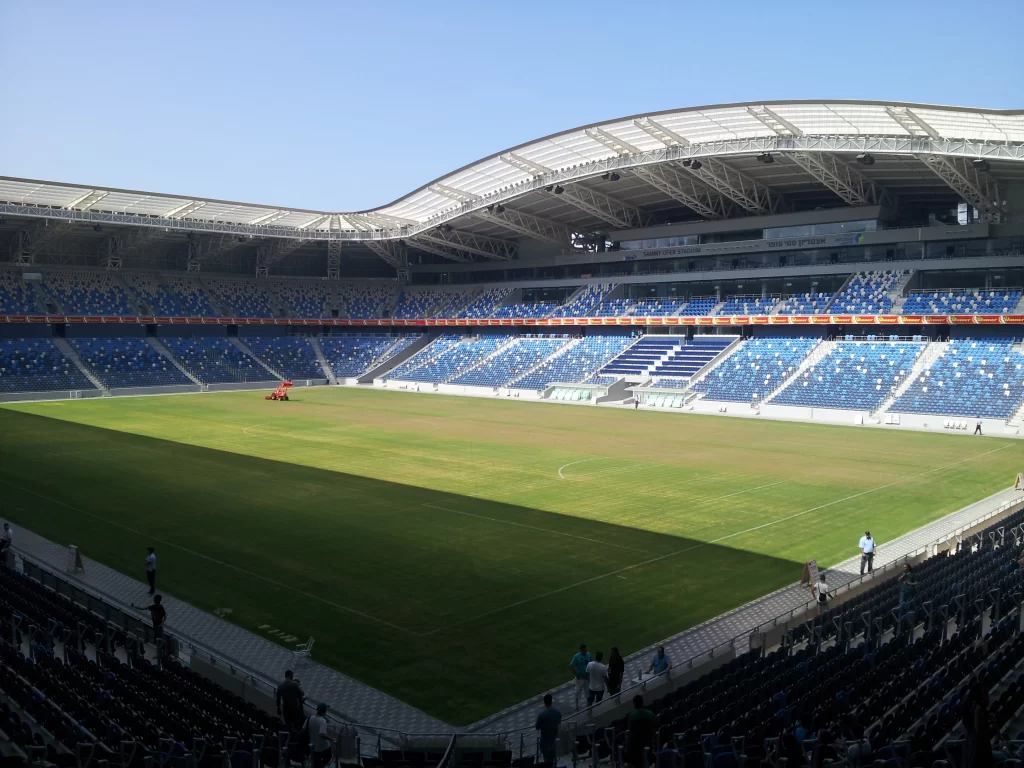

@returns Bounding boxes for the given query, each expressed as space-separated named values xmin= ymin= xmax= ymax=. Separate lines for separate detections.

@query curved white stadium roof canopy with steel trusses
xmin=0 ymin=101 xmax=1024 ymax=263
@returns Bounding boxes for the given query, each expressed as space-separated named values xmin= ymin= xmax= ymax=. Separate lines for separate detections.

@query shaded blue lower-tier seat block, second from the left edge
xmin=68 ymin=338 xmax=193 ymax=389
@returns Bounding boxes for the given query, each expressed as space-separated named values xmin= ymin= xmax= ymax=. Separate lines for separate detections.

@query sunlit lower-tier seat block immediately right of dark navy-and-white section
xmin=693 ymin=338 xmax=818 ymax=402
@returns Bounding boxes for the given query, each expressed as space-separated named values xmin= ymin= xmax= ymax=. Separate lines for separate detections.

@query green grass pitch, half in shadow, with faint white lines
xmin=0 ymin=388 xmax=1024 ymax=724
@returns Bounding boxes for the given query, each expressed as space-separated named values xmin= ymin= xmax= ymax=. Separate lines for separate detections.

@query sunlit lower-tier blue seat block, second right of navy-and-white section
xmin=772 ymin=341 xmax=926 ymax=411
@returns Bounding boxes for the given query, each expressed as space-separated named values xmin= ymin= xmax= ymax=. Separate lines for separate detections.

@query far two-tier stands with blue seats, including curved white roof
xmin=0 ymin=101 xmax=1024 ymax=433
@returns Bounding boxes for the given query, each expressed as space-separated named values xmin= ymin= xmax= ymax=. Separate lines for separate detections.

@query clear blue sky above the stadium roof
xmin=0 ymin=0 xmax=1024 ymax=211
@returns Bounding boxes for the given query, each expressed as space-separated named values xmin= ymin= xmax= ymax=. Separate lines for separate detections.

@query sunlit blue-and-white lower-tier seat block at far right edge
xmin=889 ymin=339 xmax=1024 ymax=419
